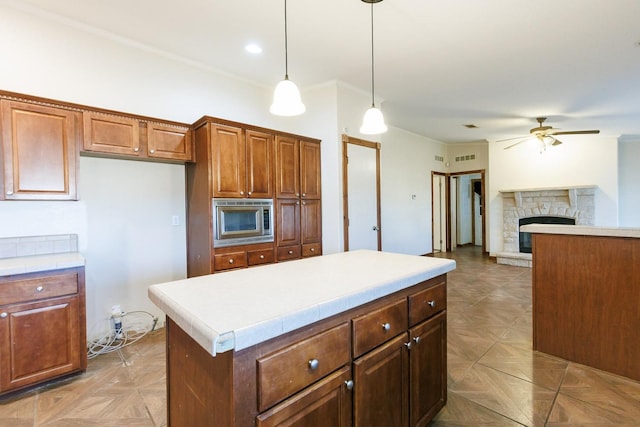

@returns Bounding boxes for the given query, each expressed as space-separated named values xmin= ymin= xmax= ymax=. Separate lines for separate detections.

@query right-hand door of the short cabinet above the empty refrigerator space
xmin=147 ymin=123 xmax=193 ymax=161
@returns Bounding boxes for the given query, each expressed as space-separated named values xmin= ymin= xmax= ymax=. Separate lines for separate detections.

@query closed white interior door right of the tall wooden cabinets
xmin=343 ymin=136 xmax=382 ymax=250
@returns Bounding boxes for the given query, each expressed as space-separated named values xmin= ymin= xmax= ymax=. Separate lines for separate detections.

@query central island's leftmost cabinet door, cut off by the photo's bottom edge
xmin=256 ymin=367 xmax=352 ymax=427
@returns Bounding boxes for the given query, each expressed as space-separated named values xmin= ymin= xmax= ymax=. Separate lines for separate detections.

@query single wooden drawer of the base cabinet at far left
xmin=0 ymin=273 xmax=78 ymax=305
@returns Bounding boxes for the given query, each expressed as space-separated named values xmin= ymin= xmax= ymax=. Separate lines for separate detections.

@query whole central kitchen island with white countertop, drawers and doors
xmin=149 ymin=250 xmax=455 ymax=427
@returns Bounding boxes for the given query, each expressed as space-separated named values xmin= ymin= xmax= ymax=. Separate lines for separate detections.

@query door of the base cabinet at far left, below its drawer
xmin=0 ymin=296 xmax=86 ymax=392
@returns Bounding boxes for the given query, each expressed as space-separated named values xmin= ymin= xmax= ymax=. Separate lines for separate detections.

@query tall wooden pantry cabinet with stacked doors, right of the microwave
xmin=276 ymin=135 xmax=322 ymax=261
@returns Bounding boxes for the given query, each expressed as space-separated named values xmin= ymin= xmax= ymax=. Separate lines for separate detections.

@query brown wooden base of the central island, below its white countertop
xmin=162 ymin=275 xmax=447 ymax=427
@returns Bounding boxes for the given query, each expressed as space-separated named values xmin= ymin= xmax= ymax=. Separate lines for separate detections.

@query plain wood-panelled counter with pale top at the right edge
xmin=520 ymin=224 xmax=640 ymax=381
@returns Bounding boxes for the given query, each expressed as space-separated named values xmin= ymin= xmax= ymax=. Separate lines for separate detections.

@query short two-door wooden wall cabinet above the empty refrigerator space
xmin=83 ymin=111 xmax=193 ymax=161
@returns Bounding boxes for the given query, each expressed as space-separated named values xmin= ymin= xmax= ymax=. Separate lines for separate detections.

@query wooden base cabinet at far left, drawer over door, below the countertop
xmin=0 ymin=267 xmax=87 ymax=394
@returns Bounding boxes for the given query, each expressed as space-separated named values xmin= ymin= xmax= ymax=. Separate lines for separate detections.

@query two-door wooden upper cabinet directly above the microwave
xmin=210 ymin=124 xmax=273 ymax=199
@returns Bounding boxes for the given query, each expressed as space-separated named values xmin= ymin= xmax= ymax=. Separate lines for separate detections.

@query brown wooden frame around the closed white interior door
xmin=342 ymin=134 xmax=382 ymax=252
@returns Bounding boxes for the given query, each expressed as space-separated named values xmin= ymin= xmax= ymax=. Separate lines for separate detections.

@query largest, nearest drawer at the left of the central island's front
xmin=257 ymin=323 xmax=349 ymax=411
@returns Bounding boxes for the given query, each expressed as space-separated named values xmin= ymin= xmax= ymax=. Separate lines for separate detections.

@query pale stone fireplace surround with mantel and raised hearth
xmin=496 ymin=185 xmax=597 ymax=267
